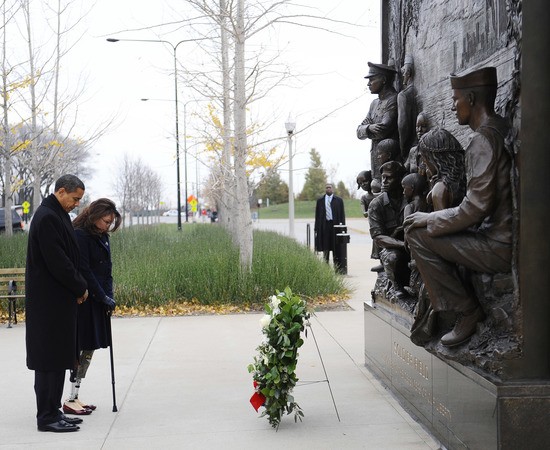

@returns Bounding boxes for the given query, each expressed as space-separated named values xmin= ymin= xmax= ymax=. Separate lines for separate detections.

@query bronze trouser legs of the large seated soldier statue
xmin=407 ymin=228 xmax=512 ymax=312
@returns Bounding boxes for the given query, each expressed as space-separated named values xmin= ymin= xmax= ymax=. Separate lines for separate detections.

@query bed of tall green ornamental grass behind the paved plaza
xmin=0 ymin=224 xmax=346 ymax=308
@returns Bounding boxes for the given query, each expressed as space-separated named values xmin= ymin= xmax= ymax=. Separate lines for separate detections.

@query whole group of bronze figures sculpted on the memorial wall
xmin=357 ymin=61 xmax=521 ymax=374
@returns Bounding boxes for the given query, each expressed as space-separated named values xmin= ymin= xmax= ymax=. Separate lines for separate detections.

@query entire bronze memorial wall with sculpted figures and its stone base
xmin=357 ymin=0 xmax=550 ymax=450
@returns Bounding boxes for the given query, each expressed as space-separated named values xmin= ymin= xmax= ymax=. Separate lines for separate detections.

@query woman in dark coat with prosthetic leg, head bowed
xmin=63 ymin=198 xmax=122 ymax=415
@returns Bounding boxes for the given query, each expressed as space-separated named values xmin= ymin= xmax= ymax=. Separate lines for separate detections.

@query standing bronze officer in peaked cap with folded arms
xmin=357 ymin=62 xmax=399 ymax=179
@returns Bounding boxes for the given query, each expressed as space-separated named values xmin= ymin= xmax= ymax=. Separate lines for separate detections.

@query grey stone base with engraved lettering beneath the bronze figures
xmin=364 ymin=298 xmax=550 ymax=450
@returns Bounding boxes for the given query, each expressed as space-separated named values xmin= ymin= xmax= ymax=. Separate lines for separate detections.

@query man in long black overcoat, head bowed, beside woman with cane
xmin=25 ymin=175 xmax=88 ymax=432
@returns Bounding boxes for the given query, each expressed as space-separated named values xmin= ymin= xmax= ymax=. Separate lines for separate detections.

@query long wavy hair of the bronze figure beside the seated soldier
xmin=418 ymin=128 xmax=466 ymax=206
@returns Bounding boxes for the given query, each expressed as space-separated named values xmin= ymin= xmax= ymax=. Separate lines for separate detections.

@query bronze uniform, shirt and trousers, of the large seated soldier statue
xmin=407 ymin=115 xmax=512 ymax=312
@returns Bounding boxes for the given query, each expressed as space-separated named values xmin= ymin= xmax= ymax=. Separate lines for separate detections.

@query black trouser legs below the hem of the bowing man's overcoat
xmin=34 ymin=370 xmax=65 ymax=426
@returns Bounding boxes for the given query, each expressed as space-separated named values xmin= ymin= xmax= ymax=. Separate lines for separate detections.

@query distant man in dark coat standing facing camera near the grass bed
xmin=314 ymin=183 xmax=346 ymax=265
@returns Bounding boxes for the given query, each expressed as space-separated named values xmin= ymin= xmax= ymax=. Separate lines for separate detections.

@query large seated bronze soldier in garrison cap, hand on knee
xmin=404 ymin=67 xmax=512 ymax=347
